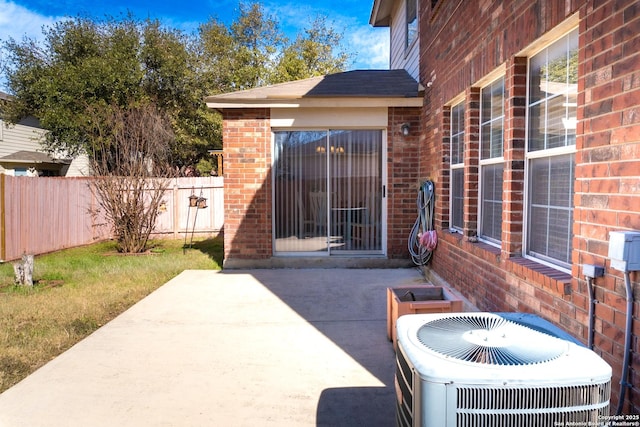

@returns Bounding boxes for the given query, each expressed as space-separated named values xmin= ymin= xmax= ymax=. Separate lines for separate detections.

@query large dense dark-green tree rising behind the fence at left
xmin=5 ymin=17 xmax=220 ymax=167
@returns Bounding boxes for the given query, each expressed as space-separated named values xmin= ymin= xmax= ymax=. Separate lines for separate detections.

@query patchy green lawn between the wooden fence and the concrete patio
xmin=0 ymin=237 xmax=222 ymax=392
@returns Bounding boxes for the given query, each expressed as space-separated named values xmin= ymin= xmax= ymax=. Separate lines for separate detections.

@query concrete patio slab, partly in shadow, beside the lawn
xmin=0 ymin=268 xmax=425 ymax=427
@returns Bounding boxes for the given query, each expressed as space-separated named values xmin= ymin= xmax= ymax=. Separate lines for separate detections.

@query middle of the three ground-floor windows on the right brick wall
xmin=479 ymin=77 xmax=504 ymax=243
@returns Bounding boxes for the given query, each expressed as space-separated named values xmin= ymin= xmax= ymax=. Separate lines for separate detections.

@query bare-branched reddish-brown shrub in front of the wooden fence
xmin=88 ymin=104 xmax=175 ymax=253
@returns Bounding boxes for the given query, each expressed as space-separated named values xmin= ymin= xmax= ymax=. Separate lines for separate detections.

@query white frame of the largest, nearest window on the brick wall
xmin=523 ymin=27 xmax=578 ymax=273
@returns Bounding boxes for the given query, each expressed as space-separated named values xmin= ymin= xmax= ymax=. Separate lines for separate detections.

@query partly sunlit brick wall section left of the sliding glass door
xmin=223 ymin=109 xmax=272 ymax=261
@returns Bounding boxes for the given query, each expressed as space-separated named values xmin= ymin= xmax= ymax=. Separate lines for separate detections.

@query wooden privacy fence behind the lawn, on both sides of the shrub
xmin=0 ymin=174 xmax=224 ymax=261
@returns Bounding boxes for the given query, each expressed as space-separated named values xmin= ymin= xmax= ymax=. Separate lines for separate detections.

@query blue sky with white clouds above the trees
xmin=0 ymin=0 xmax=389 ymax=90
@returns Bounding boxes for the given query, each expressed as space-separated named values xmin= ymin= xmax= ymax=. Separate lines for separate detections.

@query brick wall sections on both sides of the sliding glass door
xmin=223 ymin=108 xmax=422 ymax=260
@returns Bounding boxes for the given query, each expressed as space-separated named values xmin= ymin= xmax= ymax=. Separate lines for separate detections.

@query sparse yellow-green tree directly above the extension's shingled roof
xmin=198 ymin=3 xmax=350 ymax=95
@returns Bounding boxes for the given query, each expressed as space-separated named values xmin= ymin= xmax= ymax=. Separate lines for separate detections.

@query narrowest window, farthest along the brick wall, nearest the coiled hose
xmin=449 ymin=103 xmax=464 ymax=231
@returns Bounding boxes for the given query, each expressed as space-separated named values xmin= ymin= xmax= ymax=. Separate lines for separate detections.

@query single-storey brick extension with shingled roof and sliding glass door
xmin=207 ymin=69 xmax=423 ymax=268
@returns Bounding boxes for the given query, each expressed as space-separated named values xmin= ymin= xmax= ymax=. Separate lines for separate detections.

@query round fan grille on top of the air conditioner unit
xmin=418 ymin=313 xmax=566 ymax=365
